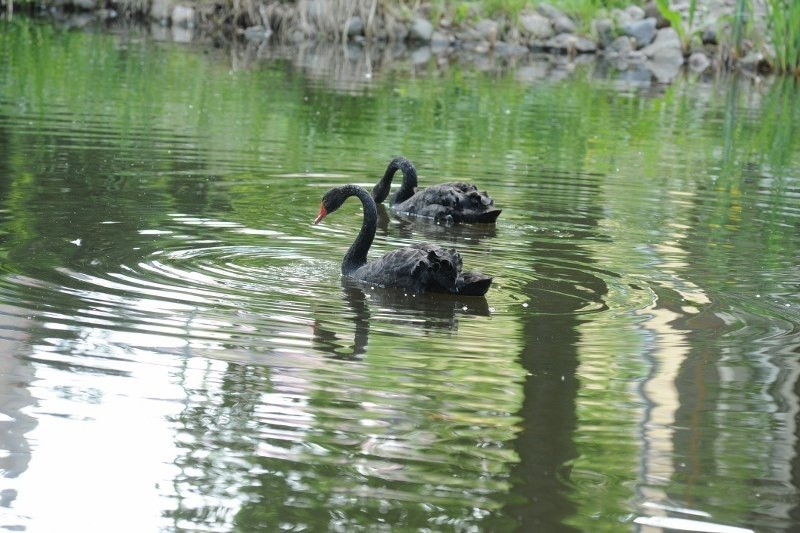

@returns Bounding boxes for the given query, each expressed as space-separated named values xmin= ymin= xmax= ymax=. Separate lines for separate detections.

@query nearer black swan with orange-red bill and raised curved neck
xmin=314 ymin=185 xmax=492 ymax=296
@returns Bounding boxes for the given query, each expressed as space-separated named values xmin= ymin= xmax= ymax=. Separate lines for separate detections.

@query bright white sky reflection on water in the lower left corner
xmin=0 ymin=318 xmax=182 ymax=531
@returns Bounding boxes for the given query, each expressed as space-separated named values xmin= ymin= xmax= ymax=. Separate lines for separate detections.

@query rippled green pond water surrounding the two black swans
xmin=0 ymin=19 xmax=800 ymax=532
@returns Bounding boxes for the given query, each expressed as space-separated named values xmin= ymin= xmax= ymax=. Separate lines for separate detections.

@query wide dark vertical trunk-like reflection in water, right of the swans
xmin=506 ymin=170 xmax=607 ymax=531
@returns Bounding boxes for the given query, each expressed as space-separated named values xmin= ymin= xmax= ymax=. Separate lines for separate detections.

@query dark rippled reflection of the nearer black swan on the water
xmin=313 ymin=277 xmax=489 ymax=359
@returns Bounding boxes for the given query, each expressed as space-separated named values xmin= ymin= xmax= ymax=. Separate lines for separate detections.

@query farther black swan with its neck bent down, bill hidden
xmin=372 ymin=157 xmax=500 ymax=223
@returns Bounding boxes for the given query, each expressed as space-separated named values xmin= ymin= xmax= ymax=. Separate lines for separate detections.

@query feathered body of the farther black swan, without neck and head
xmin=391 ymin=182 xmax=500 ymax=223
